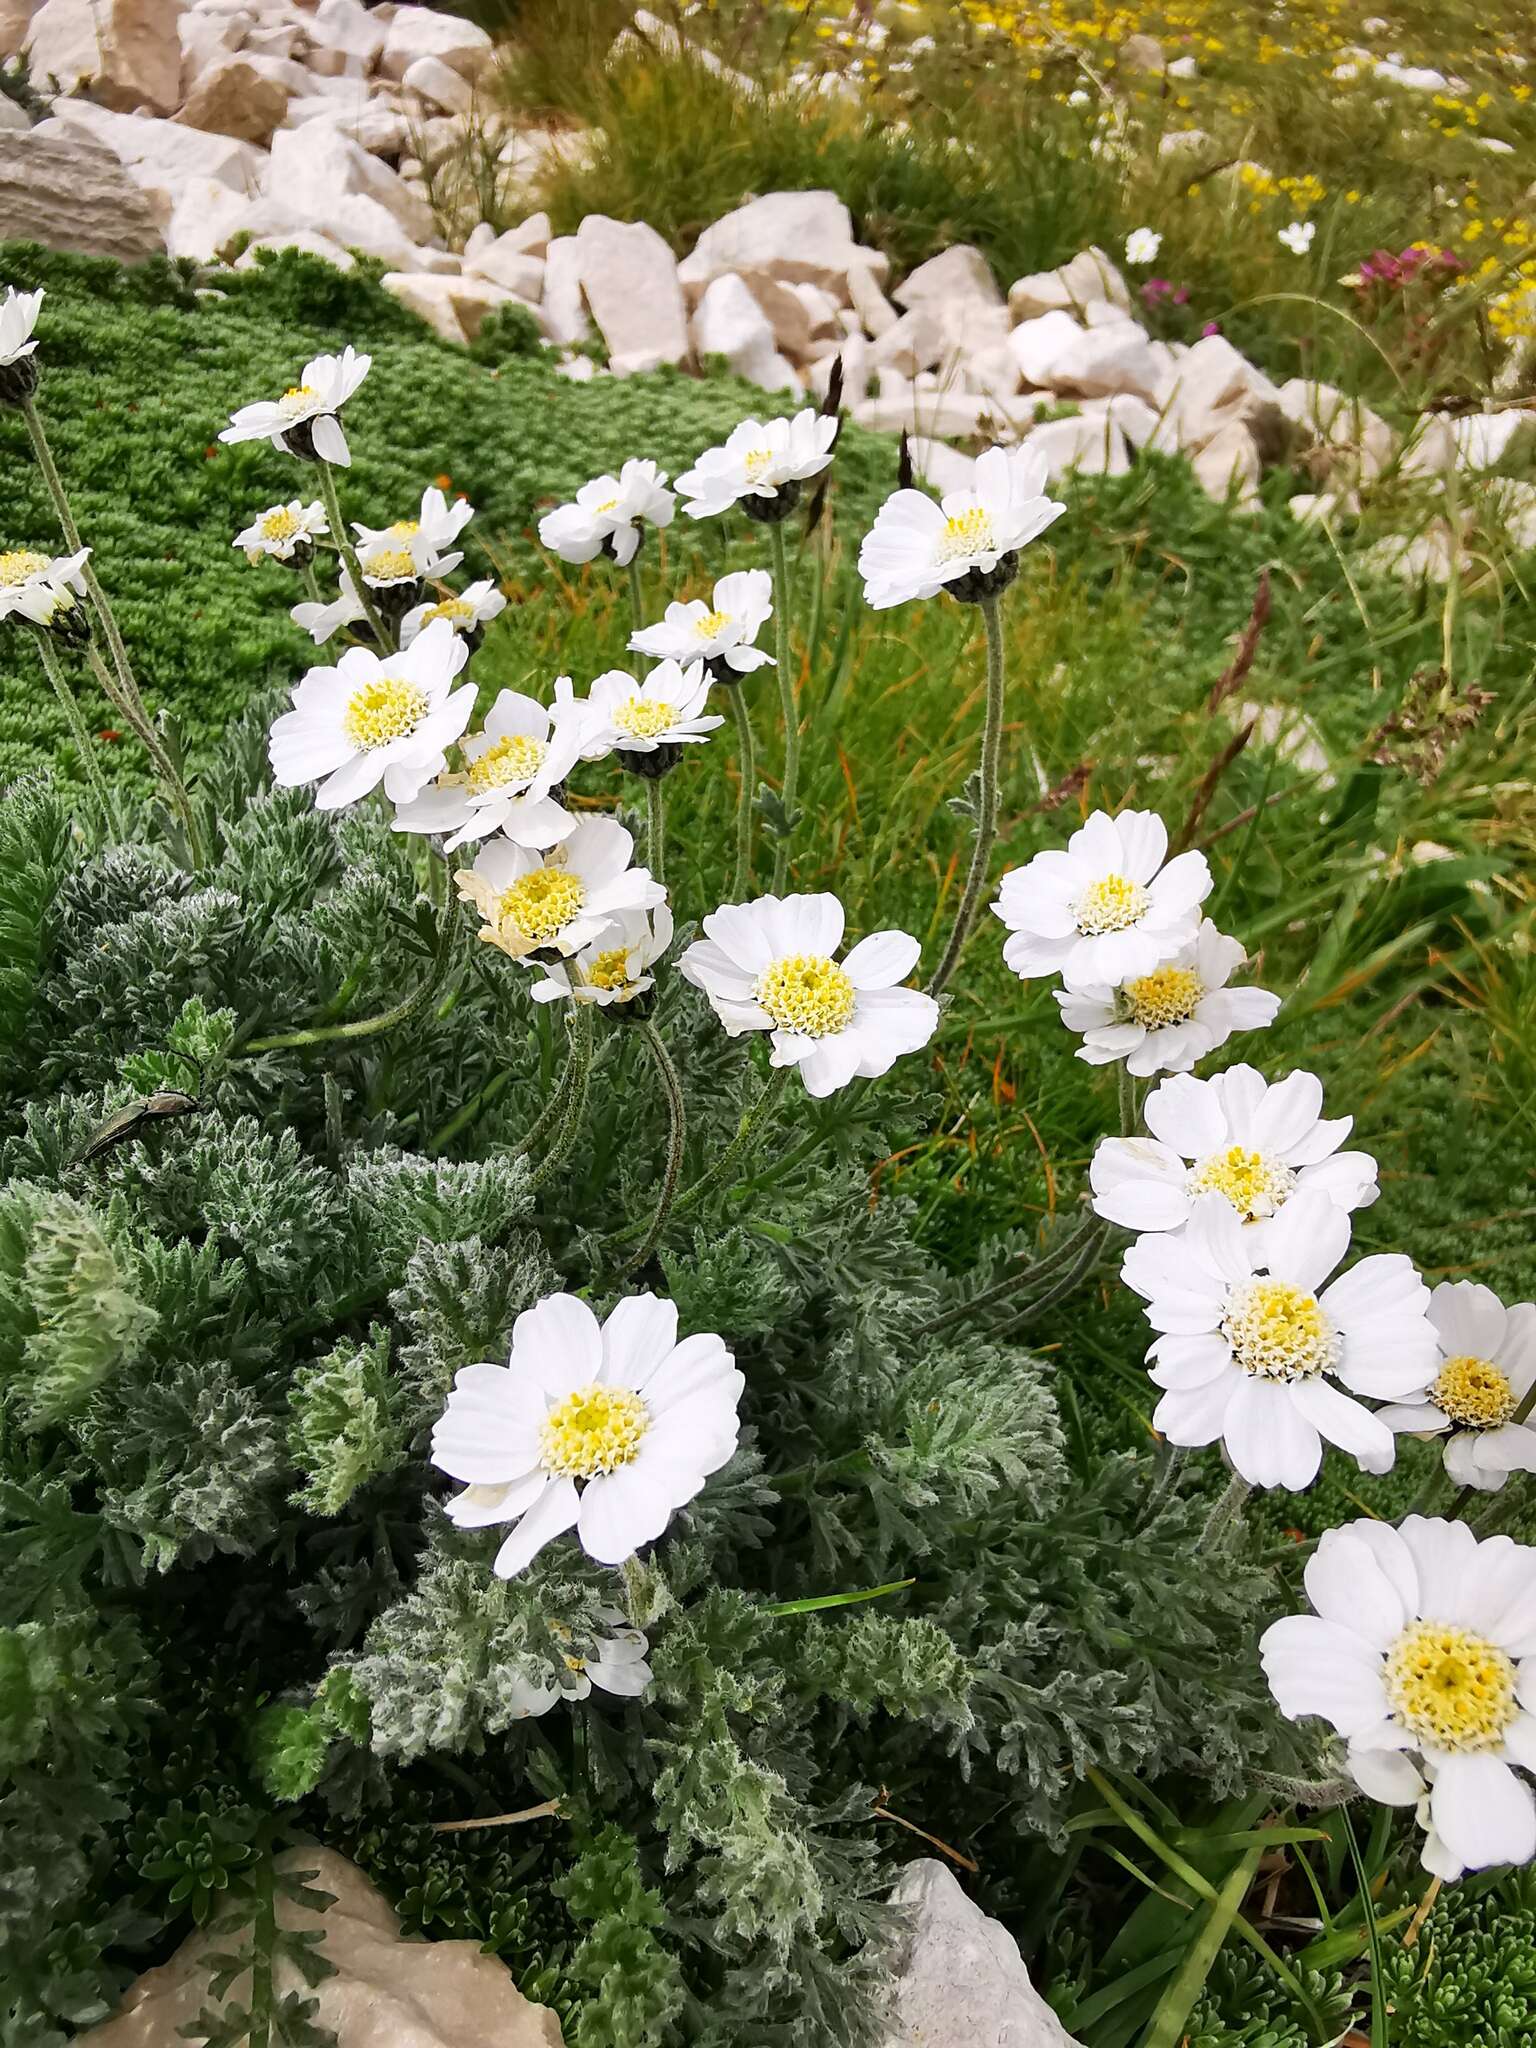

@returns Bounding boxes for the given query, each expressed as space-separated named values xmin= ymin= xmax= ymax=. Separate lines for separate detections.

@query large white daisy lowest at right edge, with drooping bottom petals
xmin=1260 ymin=1516 xmax=1536 ymax=1878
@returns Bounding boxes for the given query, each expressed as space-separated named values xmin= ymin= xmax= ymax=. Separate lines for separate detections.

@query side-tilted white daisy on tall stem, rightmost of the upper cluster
xmin=858 ymin=444 xmax=1067 ymax=612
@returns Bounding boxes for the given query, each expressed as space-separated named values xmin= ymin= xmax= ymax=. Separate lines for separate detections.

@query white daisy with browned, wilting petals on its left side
xmin=454 ymin=811 xmax=666 ymax=961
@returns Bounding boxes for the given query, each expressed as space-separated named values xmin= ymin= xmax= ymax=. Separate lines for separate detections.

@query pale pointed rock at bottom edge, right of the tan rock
xmin=883 ymin=1858 xmax=1081 ymax=2048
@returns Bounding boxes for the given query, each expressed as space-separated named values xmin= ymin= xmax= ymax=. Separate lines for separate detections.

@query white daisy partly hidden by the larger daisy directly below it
xmin=1090 ymin=1067 xmax=1376 ymax=1245
